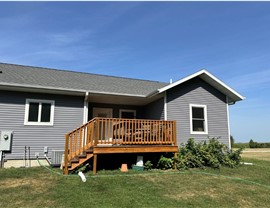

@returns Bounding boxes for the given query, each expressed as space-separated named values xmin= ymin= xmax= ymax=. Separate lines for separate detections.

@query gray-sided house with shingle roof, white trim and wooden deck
xmin=0 ymin=63 xmax=244 ymax=172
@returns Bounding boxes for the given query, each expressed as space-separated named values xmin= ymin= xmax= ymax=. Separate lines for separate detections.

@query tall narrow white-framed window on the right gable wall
xmin=190 ymin=104 xmax=208 ymax=134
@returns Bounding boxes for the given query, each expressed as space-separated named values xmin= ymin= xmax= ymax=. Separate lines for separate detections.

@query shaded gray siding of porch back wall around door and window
xmin=88 ymin=103 xmax=143 ymax=120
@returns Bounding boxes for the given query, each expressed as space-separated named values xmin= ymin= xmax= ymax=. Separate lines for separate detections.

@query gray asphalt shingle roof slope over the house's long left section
xmin=0 ymin=63 xmax=168 ymax=96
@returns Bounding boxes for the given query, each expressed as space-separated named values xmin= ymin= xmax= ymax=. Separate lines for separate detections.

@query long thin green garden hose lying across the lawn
xmin=37 ymin=158 xmax=270 ymax=189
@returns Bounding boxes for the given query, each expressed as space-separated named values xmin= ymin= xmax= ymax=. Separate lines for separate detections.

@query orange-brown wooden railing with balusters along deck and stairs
xmin=65 ymin=118 xmax=176 ymax=165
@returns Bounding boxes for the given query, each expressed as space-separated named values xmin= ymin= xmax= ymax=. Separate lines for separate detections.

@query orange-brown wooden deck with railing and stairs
xmin=64 ymin=118 xmax=178 ymax=174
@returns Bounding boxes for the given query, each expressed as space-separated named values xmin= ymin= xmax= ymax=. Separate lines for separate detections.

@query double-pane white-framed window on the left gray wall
xmin=24 ymin=99 xmax=54 ymax=126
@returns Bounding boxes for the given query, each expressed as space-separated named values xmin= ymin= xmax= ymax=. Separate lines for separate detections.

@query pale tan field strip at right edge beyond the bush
xmin=241 ymin=148 xmax=270 ymax=161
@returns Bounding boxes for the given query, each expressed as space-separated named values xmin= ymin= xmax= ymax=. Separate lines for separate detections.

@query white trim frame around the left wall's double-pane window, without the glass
xmin=24 ymin=98 xmax=54 ymax=126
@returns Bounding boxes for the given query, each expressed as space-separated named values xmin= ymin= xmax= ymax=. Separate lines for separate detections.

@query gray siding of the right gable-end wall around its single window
xmin=167 ymin=78 xmax=229 ymax=145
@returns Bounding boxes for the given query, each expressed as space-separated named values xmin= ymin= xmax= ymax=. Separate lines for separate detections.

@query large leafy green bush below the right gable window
xmin=177 ymin=138 xmax=242 ymax=169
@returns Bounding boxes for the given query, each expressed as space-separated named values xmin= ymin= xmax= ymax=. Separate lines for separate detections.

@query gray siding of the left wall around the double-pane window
xmin=0 ymin=91 xmax=84 ymax=159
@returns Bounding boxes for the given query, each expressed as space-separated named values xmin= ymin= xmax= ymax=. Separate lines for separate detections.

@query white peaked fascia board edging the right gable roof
xmin=158 ymin=69 xmax=245 ymax=100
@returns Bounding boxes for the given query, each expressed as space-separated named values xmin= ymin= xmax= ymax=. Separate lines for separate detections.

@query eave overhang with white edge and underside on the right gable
xmin=158 ymin=69 xmax=245 ymax=103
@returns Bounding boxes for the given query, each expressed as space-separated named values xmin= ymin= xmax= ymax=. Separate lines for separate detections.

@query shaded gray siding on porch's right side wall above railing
xmin=144 ymin=98 xmax=164 ymax=120
